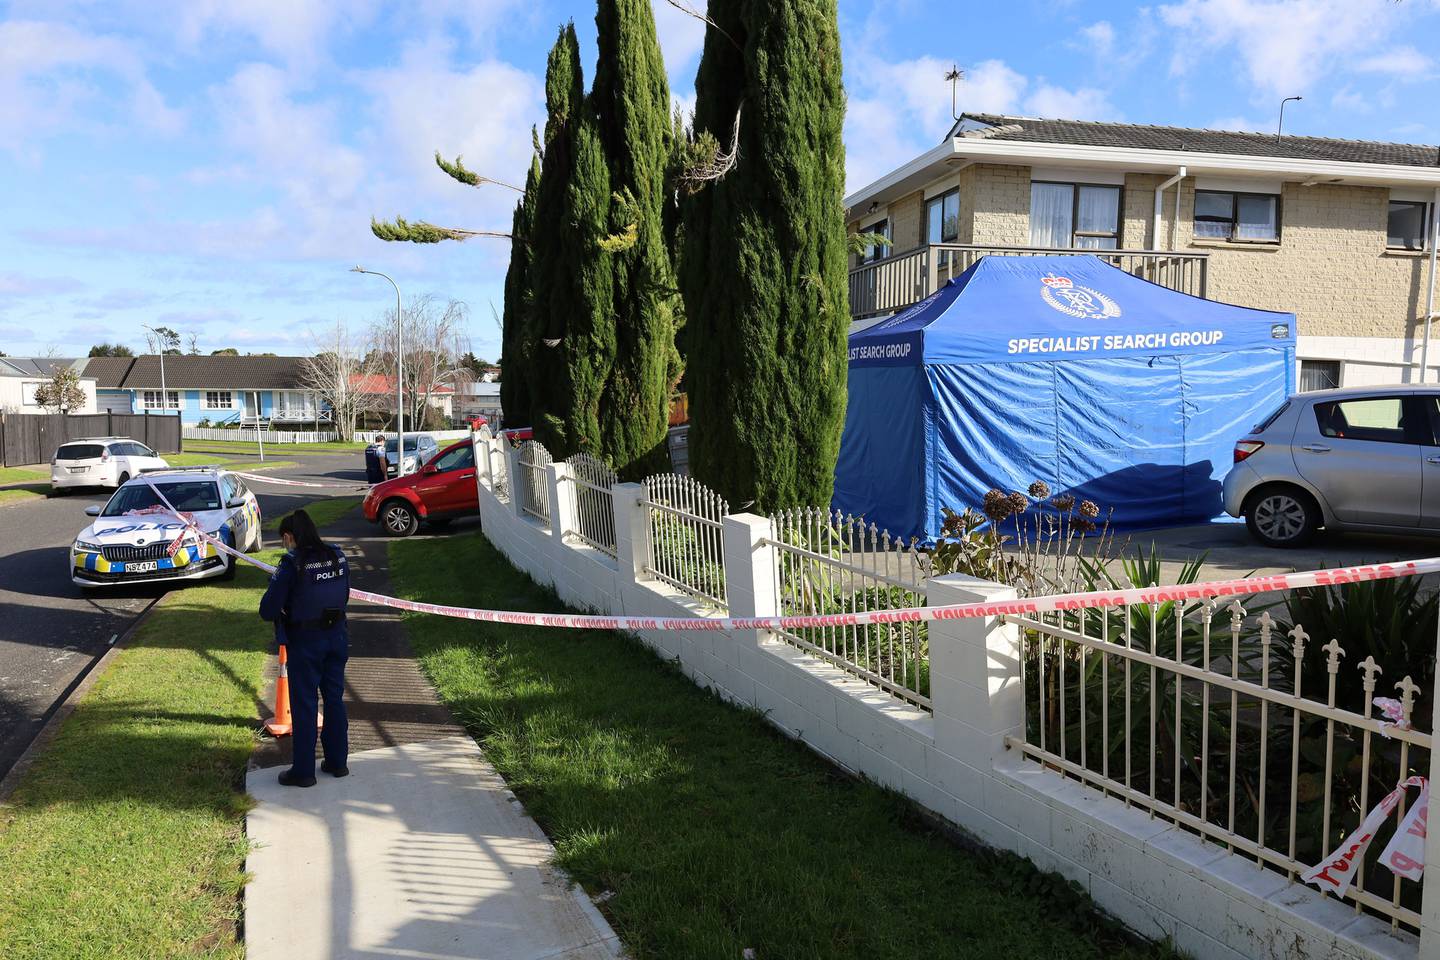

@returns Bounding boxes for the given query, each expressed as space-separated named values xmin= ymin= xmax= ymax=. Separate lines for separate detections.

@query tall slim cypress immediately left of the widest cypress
xmin=590 ymin=0 xmax=680 ymax=476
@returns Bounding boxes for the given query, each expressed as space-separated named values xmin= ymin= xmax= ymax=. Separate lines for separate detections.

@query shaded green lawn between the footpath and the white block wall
xmin=390 ymin=535 xmax=1174 ymax=960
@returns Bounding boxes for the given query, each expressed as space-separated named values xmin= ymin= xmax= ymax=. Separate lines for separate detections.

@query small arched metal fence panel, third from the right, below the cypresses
xmin=645 ymin=474 xmax=730 ymax=609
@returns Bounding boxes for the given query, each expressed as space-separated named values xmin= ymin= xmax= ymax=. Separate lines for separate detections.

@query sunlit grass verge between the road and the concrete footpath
xmin=0 ymin=551 xmax=276 ymax=960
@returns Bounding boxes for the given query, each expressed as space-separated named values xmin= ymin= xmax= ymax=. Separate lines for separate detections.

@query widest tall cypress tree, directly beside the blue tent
xmin=681 ymin=0 xmax=850 ymax=510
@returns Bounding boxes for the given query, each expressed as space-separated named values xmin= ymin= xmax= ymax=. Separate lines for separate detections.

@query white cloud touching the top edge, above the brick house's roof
xmin=1159 ymin=0 xmax=1398 ymax=99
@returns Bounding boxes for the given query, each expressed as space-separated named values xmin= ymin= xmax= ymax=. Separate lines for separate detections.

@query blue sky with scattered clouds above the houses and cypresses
xmin=0 ymin=0 xmax=1440 ymax=357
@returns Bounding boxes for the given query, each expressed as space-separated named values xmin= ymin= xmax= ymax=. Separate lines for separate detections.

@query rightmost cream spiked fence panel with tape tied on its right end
xmin=1007 ymin=587 xmax=1430 ymax=930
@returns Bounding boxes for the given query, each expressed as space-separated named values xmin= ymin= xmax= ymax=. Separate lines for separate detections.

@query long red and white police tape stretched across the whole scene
xmin=132 ymin=478 xmax=1440 ymax=630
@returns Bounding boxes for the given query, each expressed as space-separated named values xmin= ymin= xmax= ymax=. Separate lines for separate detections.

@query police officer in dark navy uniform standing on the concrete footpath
xmin=261 ymin=510 xmax=350 ymax=787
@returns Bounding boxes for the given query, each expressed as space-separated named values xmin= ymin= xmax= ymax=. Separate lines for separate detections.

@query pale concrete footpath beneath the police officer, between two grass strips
xmin=245 ymin=518 xmax=621 ymax=960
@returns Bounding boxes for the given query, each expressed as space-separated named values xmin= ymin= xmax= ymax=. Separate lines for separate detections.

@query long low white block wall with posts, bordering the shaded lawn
xmin=481 ymin=437 xmax=1440 ymax=960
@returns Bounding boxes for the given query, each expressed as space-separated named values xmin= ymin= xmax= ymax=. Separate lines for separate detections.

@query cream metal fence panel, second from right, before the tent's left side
xmin=770 ymin=508 xmax=930 ymax=710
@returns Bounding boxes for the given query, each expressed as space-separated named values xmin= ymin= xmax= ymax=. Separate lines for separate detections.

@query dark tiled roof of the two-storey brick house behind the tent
xmin=950 ymin=114 xmax=1440 ymax=167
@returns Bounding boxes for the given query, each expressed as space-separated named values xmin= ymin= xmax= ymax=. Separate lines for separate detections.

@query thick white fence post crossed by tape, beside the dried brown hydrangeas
xmin=927 ymin=574 xmax=1025 ymax=797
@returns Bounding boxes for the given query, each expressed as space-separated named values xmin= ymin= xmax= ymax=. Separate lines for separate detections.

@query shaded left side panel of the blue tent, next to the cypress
xmin=831 ymin=366 xmax=924 ymax=537
